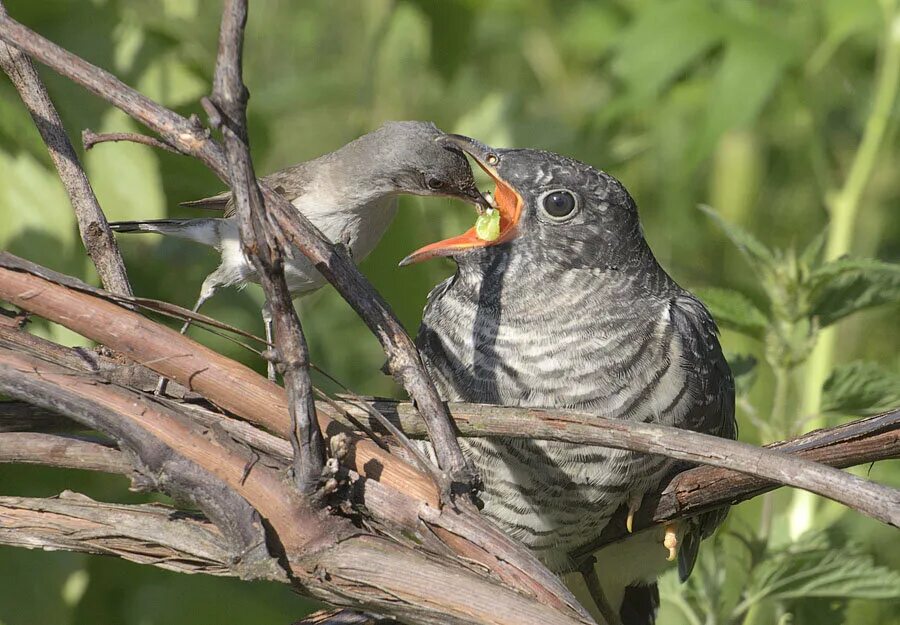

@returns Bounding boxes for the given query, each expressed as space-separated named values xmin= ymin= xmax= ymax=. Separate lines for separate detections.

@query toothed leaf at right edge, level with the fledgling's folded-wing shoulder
xmin=809 ymin=258 xmax=900 ymax=327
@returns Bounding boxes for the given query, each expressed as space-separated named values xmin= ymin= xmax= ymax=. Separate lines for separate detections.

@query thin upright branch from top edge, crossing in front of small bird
xmin=212 ymin=0 xmax=325 ymax=497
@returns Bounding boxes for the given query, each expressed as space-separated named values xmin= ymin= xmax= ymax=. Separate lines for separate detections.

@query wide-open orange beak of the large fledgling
xmin=400 ymin=135 xmax=524 ymax=267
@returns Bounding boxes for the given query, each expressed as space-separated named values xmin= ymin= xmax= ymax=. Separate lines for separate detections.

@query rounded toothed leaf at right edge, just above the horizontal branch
xmin=822 ymin=361 xmax=900 ymax=415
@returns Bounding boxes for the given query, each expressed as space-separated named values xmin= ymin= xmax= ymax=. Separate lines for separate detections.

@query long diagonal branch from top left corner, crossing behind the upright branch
xmin=0 ymin=6 xmax=474 ymax=489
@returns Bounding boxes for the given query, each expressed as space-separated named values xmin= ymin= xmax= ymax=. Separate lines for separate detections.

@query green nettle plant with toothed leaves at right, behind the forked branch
xmin=660 ymin=206 xmax=900 ymax=625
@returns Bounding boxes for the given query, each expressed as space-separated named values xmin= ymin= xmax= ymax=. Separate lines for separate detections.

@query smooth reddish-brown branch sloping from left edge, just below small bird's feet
xmin=0 ymin=252 xmax=439 ymax=506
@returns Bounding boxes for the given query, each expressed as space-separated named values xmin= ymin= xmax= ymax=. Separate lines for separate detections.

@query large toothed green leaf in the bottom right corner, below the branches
xmin=735 ymin=534 xmax=900 ymax=615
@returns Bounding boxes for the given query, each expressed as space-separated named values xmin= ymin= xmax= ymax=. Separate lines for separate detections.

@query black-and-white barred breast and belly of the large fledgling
xmin=420 ymin=262 xmax=691 ymax=571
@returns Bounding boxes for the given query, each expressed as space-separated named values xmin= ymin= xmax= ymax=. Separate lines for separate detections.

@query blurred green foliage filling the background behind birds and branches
xmin=0 ymin=0 xmax=900 ymax=625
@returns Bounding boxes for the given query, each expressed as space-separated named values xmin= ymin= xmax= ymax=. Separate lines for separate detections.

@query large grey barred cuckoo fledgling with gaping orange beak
xmin=404 ymin=135 xmax=736 ymax=625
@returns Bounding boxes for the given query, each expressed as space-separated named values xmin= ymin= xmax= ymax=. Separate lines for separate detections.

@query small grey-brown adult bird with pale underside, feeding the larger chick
xmin=110 ymin=121 xmax=486 ymax=386
